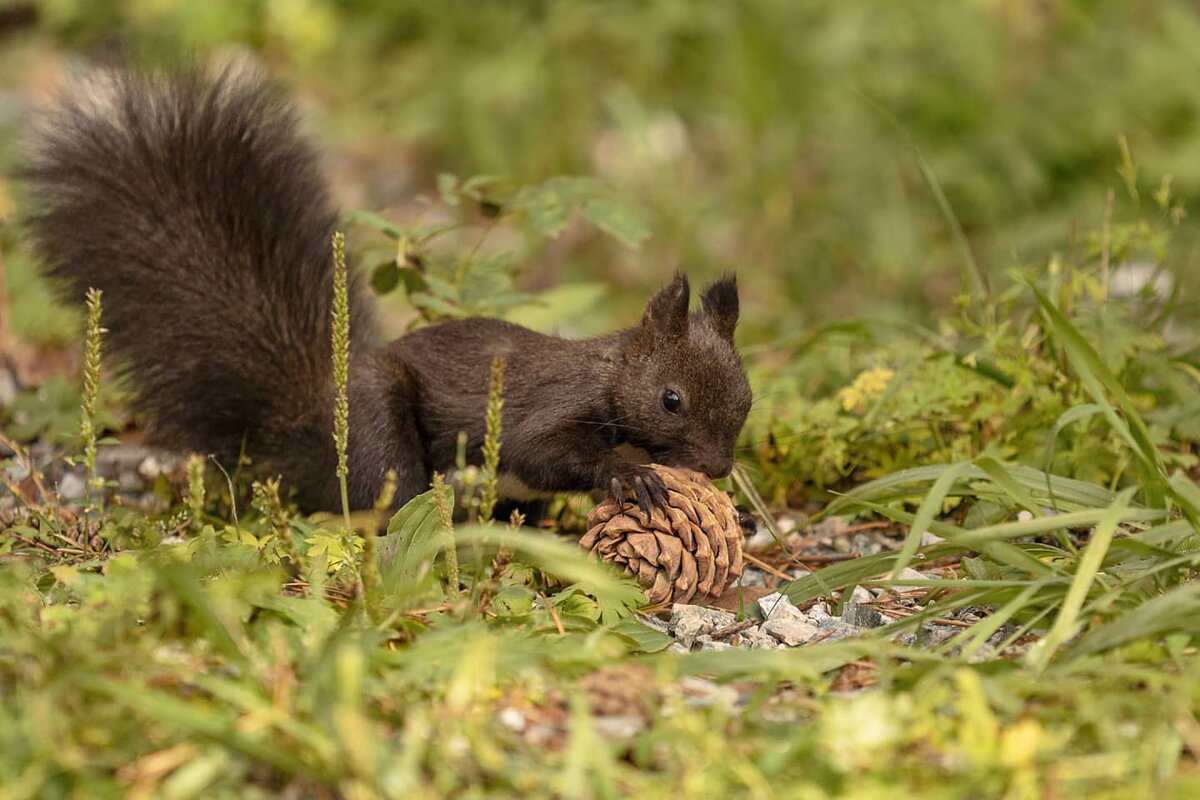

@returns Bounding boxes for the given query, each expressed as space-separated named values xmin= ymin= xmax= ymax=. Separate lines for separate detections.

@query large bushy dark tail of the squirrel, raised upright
xmin=24 ymin=67 xmax=374 ymax=489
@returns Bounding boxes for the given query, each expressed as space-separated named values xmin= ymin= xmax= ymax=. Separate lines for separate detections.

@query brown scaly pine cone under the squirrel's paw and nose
xmin=580 ymin=464 xmax=742 ymax=603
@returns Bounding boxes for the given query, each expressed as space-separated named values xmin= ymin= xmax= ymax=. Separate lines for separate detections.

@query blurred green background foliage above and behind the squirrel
xmin=0 ymin=0 xmax=1200 ymax=341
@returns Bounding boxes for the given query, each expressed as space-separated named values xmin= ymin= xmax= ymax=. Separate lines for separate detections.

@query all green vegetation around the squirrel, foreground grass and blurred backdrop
xmin=7 ymin=0 xmax=1200 ymax=800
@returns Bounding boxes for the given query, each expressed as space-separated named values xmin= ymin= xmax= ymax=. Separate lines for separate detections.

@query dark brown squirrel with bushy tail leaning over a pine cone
xmin=24 ymin=62 xmax=750 ymax=510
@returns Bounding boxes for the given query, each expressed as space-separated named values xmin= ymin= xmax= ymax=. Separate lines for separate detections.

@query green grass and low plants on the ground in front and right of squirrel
xmin=0 ymin=178 xmax=1200 ymax=798
